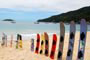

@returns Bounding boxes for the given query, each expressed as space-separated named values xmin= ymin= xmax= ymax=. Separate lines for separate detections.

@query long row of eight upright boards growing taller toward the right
xmin=31 ymin=19 xmax=87 ymax=60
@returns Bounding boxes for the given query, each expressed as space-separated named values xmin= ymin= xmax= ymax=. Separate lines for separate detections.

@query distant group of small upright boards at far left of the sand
xmin=1 ymin=33 xmax=22 ymax=49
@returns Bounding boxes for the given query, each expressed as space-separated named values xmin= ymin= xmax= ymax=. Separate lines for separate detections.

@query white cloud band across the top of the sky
xmin=0 ymin=0 xmax=90 ymax=12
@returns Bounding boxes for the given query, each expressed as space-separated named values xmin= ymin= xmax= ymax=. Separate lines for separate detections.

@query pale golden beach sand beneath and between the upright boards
xmin=0 ymin=32 xmax=90 ymax=60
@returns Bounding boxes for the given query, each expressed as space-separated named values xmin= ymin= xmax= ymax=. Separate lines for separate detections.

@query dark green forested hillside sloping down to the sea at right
xmin=37 ymin=6 xmax=90 ymax=23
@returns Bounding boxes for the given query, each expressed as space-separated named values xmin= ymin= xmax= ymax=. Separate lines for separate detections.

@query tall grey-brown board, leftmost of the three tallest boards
xmin=57 ymin=22 xmax=65 ymax=60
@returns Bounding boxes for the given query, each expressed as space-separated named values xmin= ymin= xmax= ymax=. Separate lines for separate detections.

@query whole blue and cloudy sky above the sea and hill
xmin=0 ymin=0 xmax=90 ymax=21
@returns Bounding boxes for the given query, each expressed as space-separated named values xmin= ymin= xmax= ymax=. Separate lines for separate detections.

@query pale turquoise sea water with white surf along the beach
xmin=0 ymin=21 xmax=90 ymax=40
